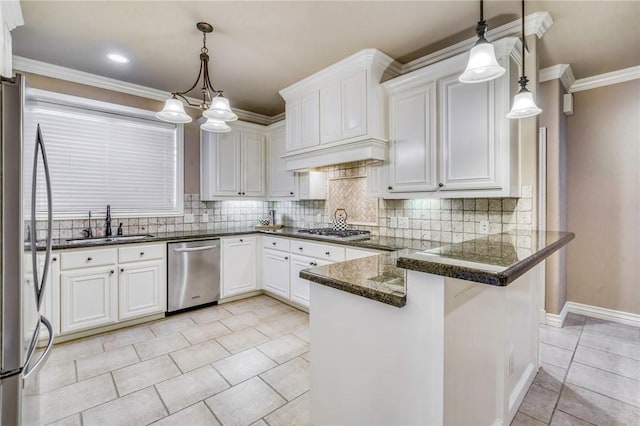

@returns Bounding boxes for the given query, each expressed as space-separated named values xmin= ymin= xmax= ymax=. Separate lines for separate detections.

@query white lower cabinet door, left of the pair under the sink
xmin=60 ymin=265 xmax=118 ymax=333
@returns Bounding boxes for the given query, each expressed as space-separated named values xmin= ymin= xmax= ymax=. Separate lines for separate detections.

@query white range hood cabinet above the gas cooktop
xmin=280 ymin=49 xmax=400 ymax=170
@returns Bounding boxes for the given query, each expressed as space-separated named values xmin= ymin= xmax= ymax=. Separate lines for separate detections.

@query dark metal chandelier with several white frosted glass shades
xmin=156 ymin=22 xmax=238 ymax=133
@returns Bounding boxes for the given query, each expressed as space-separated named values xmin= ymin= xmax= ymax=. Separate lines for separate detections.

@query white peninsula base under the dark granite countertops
xmin=310 ymin=266 xmax=541 ymax=425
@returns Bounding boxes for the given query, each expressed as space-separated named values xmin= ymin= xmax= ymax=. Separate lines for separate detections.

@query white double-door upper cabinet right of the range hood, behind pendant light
xmin=380 ymin=38 xmax=520 ymax=198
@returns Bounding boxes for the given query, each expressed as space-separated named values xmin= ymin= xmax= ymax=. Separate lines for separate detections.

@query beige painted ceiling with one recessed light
xmin=12 ymin=0 xmax=640 ymax=116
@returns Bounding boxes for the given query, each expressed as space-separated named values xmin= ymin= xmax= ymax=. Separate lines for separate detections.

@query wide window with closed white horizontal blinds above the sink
xmin=24 ymin=90 xmax=183 ymax=219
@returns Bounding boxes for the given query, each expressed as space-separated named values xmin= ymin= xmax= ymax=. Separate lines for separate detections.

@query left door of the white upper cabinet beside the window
xmin=212 ymin=130 xmax=241 ymax=197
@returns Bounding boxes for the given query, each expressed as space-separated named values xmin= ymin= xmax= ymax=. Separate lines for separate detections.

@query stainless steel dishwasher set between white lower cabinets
xmin=167 ymin=238 xmax=220 ymax=312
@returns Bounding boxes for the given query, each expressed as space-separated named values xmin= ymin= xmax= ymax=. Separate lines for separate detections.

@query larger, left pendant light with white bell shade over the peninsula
xmin=458 ymin=0 xmax=506 ymax=83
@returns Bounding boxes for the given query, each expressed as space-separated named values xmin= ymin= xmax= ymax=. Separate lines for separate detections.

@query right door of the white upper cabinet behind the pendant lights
xmin=438 ymin=74 xmax=500 ymax=190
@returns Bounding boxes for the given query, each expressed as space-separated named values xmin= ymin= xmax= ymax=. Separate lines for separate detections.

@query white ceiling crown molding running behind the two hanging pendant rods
xmin=402 ymin=12 xmax=553 ymax=74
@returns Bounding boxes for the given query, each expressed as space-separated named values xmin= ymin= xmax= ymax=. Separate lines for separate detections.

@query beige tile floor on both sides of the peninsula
xmin=26 ymin=296 xmax=640 ymax=426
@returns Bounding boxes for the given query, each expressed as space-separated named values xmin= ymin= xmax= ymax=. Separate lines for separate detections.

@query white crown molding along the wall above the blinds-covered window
xmin=13 ymin=56 xmax=279 ymax=126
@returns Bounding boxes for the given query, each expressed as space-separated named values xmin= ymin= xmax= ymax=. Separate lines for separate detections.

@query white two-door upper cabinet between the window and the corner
xmin=200 ymin=123 xmax=266 ymax=201
